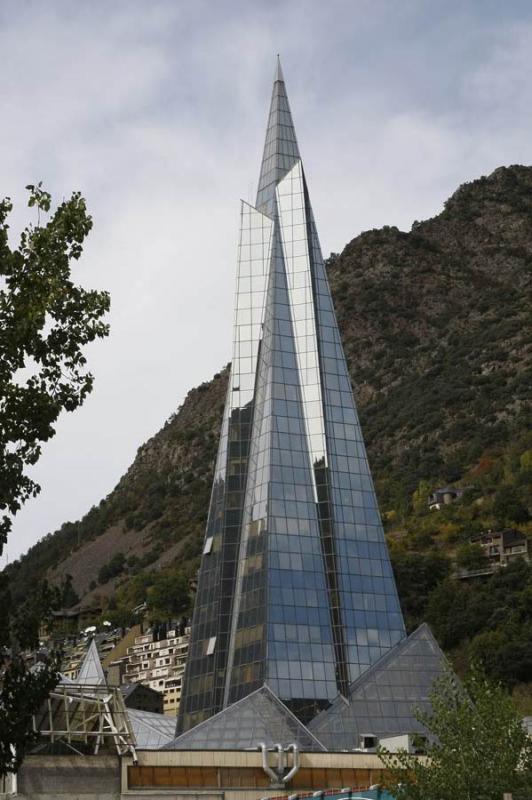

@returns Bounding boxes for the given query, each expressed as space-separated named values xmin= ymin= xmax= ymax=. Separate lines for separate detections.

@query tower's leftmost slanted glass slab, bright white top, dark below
xmin=179 ymin=203 xmax=273 ymax=729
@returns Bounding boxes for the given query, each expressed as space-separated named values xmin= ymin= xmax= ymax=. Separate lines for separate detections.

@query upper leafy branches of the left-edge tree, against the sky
xmin=0 ymin=184 xmax=109 ymax=552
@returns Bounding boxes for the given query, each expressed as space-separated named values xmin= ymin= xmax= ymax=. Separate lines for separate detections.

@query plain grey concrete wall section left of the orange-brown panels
xmin=18 ymin=755 xmax=120 ymax=800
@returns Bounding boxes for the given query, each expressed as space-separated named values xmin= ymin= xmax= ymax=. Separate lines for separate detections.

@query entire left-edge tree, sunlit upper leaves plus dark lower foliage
xmin=0 ymin=184 xmax=109 ymax=775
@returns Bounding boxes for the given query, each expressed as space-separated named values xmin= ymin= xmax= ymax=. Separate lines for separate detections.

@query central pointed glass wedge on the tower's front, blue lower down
xmin=225 ymin=223 xmax=337 ymax=713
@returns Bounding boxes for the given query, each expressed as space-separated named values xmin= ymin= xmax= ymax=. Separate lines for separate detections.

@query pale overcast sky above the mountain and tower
xmin=0 ymin=0 xmax=532 ymax=561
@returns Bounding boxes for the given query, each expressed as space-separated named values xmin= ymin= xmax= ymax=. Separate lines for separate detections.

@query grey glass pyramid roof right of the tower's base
xmin=309 ymin=623 xmax=447 ymax=751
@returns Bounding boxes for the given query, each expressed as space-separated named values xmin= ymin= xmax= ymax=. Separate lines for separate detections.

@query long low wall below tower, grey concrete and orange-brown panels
xmin=13 ymin=750 xmax=394 ymax=800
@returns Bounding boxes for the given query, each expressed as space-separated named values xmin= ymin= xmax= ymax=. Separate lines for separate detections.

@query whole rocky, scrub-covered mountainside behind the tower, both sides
xmin=4 ymin=166 xmax=532 ymax=682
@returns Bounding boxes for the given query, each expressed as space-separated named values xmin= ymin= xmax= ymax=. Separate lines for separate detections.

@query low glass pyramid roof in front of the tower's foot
xmin=162 ymin=686 xmax=325 ymax=752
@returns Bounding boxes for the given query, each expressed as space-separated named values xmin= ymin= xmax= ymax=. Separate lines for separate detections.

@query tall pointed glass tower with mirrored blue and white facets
xmin=178 ymin=59 xmax=405 ymax=732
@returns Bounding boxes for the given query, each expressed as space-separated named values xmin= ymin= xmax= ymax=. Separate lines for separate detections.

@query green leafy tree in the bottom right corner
xmin=380 ymin=668 xmax=532 ymax=800
